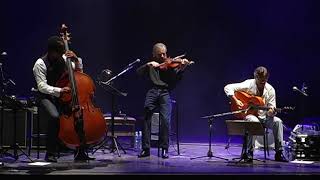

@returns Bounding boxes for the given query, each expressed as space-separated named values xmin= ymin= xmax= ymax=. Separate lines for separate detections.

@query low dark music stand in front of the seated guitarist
xmin=226 ymin=120 xmax=265 ymax=162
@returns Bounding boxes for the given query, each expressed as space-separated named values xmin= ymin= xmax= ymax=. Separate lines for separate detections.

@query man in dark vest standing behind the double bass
xmin=33 ymin=36 xmax=82 ymax=162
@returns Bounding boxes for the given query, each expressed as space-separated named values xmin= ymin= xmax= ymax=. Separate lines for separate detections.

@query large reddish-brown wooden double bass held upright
xmin=57 ymin=24 xmax=107 ymax=148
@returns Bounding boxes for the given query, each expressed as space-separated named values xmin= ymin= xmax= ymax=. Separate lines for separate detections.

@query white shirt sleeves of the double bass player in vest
xmin=32 ymin=55 xmax=83 ymax=97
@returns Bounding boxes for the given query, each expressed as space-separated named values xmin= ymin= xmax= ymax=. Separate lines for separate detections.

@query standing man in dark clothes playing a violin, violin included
xmin=137 ymin=43 xmax=191 ymax=159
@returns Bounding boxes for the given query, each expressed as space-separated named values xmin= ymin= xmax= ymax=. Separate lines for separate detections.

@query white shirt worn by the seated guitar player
xmin=224 ymin=79 xmax=276 ymax=119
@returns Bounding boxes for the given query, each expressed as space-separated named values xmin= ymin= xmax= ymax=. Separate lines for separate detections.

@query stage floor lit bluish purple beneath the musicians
xmin=0 ymin=143 xmax=320 ymax=175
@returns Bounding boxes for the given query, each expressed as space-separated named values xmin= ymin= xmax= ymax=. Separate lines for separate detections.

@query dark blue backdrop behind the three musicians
xmin=0 ymin=0 xmax=320 ymax=143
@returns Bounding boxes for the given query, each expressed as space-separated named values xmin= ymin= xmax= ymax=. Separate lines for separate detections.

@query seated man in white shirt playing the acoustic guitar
xmin=224 ymin=66 xmax=286 ymax=162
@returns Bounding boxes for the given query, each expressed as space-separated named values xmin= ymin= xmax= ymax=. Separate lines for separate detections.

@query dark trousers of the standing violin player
xmin=142 ymin=87 xmax=172 ymax=149
